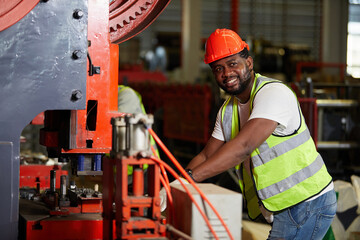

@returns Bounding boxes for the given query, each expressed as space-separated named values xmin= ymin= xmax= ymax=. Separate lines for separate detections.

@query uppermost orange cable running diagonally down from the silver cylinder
xmin=147 ymin=128 xmax=234 ymax=240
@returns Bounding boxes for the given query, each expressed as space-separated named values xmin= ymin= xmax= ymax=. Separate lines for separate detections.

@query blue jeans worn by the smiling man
xmin=268 ymin=190 xmax=337 ymax=240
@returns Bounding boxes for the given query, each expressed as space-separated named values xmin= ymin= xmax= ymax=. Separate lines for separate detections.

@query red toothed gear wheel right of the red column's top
xmin=109 ymin=0 xmax=170 ymax=43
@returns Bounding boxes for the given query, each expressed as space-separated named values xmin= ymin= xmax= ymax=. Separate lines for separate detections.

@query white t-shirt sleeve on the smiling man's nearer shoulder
xmin=249 ymin=83 xmax=300 ymax=135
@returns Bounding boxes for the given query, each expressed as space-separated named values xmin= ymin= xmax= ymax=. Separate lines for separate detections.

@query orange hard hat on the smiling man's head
xmin=204 ymin=29 xmax=250 ymax=64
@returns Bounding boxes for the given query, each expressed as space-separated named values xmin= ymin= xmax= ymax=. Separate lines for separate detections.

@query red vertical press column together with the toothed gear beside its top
xmin=40 ymin=0 xmax=170 ymax=159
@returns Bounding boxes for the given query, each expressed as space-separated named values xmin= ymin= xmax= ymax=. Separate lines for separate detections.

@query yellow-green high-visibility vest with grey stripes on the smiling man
xmin=221 ymin=74 xmax=332 ymax=219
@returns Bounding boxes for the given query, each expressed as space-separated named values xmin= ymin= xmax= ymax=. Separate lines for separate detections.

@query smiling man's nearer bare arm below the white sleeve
xmin=188 ymin=118 xmax=278 ymax=182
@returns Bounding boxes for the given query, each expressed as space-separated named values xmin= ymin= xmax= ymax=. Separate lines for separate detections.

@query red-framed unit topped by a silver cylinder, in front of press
xmin=103 ymin=114 xmax=166 ymax=239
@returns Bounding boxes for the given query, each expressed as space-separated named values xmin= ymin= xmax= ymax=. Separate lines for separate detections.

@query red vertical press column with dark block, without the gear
xmin=40 ymin=1 xmax=119 ymax=156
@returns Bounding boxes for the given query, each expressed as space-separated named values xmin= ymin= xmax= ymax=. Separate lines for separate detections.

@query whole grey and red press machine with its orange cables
xmin=0 ymin=0 xmax=239 ymax=240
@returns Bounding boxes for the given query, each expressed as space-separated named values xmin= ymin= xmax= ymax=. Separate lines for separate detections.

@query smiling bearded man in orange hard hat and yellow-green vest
xmin=186 ymin=29 xmax=336 ymax=239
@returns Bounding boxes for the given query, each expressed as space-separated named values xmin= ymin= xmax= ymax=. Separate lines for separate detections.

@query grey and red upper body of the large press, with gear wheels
xmin=0 ymin=0 xmax=169 ymax=239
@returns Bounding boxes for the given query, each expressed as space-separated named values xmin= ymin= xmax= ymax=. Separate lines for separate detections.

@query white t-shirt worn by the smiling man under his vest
xmin=212 ymin=79 xmax=334 ymax=217
